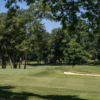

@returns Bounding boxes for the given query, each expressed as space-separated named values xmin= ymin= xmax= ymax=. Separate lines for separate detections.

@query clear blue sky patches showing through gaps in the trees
xmin=0 ymin=0 xmax=61 ymax=33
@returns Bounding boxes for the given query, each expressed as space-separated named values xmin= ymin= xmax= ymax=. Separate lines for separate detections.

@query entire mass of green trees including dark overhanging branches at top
xmin=0 ymin=0 xmax=100 ymax=69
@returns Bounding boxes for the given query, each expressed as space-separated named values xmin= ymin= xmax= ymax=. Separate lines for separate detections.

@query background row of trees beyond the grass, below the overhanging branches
xmin=0 ymin=6 xmax=99 ymax=69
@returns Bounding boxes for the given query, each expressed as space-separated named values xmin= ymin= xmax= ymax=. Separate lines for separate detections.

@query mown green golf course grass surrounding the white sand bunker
xmin=0 ymin=65 xmax=100 ymax=100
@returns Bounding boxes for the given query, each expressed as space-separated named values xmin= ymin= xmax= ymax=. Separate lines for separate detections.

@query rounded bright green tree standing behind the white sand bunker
xmin=64 ymin=40 xmax=89 ymax=66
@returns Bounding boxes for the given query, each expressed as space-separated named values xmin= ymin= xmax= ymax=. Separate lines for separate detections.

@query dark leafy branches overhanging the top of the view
xmin=5 ymin=0 xmax=100 ymax=31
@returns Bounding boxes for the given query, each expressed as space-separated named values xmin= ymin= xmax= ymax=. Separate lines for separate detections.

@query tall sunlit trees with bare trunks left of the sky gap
xmin=0 ymin=3 xmax=50 ymax=68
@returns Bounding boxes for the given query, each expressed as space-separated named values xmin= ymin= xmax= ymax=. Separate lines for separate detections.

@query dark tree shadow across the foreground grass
xmin=0 ymin=86 xmax=86 ymax=100
